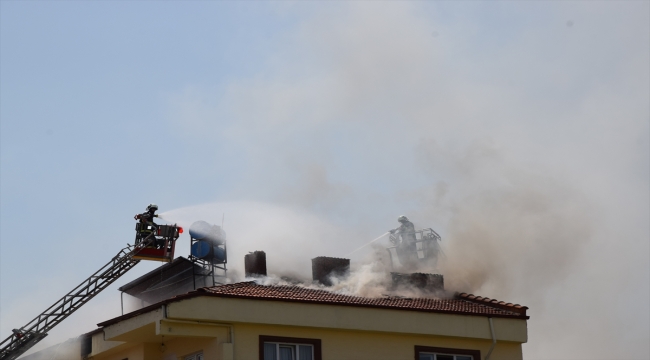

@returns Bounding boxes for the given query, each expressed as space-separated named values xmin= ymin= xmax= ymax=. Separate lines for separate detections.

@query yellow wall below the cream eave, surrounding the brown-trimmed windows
xmin=93 ymin=324 xmax=522 ymax=360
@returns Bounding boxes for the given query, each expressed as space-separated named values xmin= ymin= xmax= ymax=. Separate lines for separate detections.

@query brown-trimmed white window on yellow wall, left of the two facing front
xmin=260 ymin=335 xmax=322 ymax=360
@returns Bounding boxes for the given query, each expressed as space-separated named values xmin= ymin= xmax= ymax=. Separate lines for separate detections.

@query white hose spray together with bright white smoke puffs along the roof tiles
xmin=161 ymin=202 xmax=442 ymax=297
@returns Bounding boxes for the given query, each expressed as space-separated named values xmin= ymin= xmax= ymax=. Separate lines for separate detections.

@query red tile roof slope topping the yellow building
xmin=198 ymin=281 xmax=528 ymax=319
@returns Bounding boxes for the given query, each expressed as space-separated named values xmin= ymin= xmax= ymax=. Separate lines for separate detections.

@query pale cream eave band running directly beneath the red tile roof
xmin=167 ymin=296 xmax=528 ymax=343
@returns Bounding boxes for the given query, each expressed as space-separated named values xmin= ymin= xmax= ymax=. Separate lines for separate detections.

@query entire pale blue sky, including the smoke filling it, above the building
xmin=0 ymin=1 xmax=650 ymax=359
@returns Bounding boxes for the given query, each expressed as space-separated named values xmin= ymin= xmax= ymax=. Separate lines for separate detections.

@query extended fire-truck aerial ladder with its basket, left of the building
xmin=0 ymin=223 xmax=183 ymax=360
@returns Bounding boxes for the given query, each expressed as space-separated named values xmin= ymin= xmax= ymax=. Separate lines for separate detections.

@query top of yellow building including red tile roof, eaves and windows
xmin=81 ymin=282 xmax=528 ymax=360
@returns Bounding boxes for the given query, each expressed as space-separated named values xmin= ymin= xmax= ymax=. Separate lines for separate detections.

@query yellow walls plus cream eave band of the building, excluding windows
xmin=93 ymin=297 xmax=527 ymax=360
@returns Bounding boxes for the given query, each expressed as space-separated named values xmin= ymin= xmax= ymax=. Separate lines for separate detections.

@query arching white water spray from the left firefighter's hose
xmin=161 ymin=201 xmax=354 ymax=280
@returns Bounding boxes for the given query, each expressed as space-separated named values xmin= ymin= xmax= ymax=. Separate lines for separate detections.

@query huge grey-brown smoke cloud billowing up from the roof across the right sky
xmin=165 ymin=2 xmax=650 ymax=359
